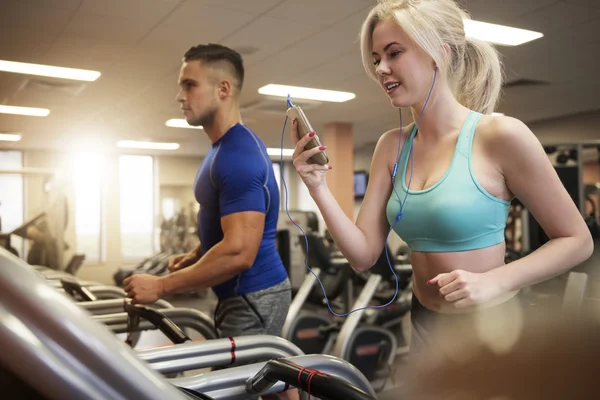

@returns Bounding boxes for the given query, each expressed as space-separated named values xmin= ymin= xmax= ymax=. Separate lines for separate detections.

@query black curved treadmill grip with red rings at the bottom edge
xmin=246 ymin=359 xmax=374 ymax=400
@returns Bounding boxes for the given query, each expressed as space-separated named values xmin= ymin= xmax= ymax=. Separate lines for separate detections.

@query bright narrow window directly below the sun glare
xmin=73 ymin=153 xmax=106 ymax=264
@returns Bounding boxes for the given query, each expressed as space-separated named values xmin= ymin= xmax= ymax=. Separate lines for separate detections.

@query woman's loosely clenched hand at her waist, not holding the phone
xmin=427 ymin=269 xmax=503 ymax=308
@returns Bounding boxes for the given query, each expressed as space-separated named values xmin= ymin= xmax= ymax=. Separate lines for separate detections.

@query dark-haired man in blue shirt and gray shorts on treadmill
xmin=124 ymin=44 xmax=291 ymax=337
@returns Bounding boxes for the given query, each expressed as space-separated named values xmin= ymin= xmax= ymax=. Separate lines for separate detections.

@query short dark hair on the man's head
xmin=183 ymin=43 xmax=244 ymax=92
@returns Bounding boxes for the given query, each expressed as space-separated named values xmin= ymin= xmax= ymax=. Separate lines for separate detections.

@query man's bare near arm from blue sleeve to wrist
xmin=160 ymin=211 xmax=265 ymax=297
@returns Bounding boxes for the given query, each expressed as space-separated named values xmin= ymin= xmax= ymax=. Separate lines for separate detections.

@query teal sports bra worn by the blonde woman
xmin=386 ymin=111 xmax=510 ymax=252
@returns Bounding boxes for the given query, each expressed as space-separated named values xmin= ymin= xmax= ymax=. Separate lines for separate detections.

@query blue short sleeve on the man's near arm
xmin=214 ymin=154 xmax=268 ymax=217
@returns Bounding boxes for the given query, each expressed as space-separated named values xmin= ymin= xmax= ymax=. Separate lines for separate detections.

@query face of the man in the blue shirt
xmin=177 ymin=61 xmax=218 ymax=126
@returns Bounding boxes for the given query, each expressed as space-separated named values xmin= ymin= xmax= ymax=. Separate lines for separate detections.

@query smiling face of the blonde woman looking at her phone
xmin=372 ymin=19 xmax=435 ymax=107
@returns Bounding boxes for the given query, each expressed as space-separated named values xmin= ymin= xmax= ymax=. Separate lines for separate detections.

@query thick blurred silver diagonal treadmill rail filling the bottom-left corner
xmin=0 ymin=248 xmax=186 ymax=400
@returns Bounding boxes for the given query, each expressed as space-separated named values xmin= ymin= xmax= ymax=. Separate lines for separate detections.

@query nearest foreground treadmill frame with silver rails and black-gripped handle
xmin=0 ymin=249 xmax=376 ymax=400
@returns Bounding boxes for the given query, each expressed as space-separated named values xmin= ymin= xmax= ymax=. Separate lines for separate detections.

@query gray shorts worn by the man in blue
xmin=214 ymin=279 xmax=292 ymax=337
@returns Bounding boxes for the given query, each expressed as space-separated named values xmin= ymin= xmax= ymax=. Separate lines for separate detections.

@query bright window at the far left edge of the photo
xmin=0 ymin=151 xmax=26 ymax=258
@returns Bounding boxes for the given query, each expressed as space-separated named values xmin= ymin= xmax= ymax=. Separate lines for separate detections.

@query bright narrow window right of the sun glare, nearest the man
xmin=119 ymin=155 xmax=154 ymax=260
